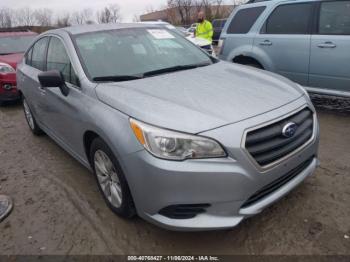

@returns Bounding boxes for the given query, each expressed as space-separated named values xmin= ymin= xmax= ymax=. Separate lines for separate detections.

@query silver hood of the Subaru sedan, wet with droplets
xmin=96 ymin=62 xmax=303 ymax=133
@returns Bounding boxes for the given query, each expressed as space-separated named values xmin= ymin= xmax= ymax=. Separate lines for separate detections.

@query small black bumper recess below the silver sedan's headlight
xmin=159 ymin=204 xmax=210 ymax=219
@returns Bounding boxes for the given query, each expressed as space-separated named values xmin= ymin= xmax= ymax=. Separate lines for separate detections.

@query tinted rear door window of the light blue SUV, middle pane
xmin=263 ymin=3 xmax=313 ymax=35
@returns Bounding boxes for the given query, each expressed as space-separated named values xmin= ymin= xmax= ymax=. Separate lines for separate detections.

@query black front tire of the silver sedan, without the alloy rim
xmin=90 ymin=138 xmax=135 ymax=218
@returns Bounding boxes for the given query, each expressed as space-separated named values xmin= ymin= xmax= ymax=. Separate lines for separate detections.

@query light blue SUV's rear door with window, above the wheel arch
xmin=253 ymin=2 xmax=315 ymax=85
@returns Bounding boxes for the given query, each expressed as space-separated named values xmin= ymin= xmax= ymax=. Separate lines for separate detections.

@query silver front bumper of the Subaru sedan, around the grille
xmin=122 ymin=100 xmax=319 ymax=231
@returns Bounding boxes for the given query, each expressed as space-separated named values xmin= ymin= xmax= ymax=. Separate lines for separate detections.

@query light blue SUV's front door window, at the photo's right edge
xmin=318 ymin=1 xmax=350 ymax=35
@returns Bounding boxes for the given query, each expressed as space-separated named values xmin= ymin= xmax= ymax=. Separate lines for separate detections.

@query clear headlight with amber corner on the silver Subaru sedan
xmin=130 ymin=119 xmax=226 ymax=160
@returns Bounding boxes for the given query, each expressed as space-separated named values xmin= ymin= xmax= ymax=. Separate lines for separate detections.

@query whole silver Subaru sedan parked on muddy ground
xmin=17 ymin=24 xmax=319 ymax=231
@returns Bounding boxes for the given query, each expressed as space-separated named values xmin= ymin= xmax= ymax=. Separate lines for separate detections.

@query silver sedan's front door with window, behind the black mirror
xmin=43 ymin=37 xmax=83 ymax=154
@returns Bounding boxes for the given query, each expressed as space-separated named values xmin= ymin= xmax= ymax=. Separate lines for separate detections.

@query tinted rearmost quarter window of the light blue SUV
xmin=227 ymin=6 xmax=266 ymax=34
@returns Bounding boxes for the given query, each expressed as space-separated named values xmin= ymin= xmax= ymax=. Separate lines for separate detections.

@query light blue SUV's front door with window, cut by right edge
xmin=309 ymin=0 xmax=350 ymax=91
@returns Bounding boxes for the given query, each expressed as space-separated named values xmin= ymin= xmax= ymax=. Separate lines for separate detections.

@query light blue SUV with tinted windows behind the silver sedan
xmin=220 ymin=0 xmax=350 ymax=96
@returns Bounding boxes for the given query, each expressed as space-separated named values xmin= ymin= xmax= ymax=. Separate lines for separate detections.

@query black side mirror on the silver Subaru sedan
xmin=38 ymin=70 xmax=69 ymax=96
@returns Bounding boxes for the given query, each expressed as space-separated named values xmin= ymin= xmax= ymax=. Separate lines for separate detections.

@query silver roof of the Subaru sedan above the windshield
xmin=47 ymin=23 xmax=161 ymax=35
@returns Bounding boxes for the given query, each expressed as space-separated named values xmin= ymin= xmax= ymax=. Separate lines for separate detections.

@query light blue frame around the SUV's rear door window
xmin=259 ymin=2 xmax=320 ymax=35
